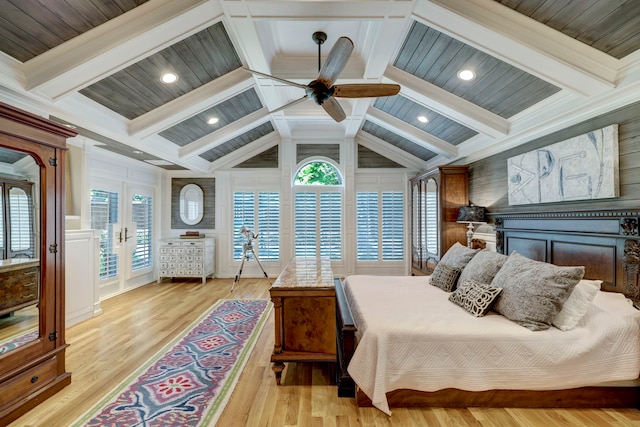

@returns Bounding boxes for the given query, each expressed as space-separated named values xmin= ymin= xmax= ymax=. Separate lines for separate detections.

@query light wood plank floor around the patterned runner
xmin=10 ymin=279 xmax=640 ymax=427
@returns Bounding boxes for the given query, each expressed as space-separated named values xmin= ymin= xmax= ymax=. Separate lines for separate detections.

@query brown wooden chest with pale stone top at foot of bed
xmin=269 ymin=257 xmax=336 ymax=384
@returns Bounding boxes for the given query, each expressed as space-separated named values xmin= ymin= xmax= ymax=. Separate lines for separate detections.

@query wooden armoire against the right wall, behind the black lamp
xmin=410 ymin=165 xmax=469 ymax=275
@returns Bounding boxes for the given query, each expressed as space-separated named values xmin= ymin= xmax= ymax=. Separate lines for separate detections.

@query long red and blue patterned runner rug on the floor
xmin=73 ymin=300 xmax=271 ymax=427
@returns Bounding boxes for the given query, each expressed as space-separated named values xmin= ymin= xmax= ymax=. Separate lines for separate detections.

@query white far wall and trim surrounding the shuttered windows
xmin=161 ymin=135 xmax=415 ymax=278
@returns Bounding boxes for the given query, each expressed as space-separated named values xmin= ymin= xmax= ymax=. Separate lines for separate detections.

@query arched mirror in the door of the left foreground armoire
xmin=0 ymin=147 xmax=41 ymax=354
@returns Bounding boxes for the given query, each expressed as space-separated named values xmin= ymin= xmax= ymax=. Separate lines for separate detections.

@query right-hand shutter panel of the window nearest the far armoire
xmin=382 ymin=192 xmax=404 ymax=260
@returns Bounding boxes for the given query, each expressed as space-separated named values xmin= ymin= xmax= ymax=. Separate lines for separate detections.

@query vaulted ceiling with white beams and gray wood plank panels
xmin=0 ymin=0 xmax=640 ymax=172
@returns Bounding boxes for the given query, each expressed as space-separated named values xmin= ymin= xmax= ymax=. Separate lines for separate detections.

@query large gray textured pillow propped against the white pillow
xmin=491 ymin=251 xmax=584 ymax=331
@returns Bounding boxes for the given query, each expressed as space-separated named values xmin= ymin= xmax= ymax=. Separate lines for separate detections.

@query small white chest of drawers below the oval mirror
xmin=158 ymin=237 xmax=215 ymax=283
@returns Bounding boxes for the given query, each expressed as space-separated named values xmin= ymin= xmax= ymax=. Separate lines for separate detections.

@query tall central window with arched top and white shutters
xmin=293 ymin=160 xmax=343 ymax=260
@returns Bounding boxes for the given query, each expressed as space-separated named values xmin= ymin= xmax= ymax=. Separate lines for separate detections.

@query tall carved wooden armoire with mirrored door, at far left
xmin=0 ymin=103 xmax=76 ymax=425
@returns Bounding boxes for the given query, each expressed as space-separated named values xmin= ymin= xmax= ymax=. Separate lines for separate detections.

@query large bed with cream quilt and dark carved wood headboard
xmin=336 ymin=211 xmax=640 ymax=414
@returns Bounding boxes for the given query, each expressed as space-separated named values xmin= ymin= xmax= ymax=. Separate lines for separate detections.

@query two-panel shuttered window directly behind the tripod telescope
xmin=233 ymin=192 xmax=280 ymax=261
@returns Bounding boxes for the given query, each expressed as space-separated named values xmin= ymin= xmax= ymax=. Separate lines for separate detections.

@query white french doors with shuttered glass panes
xmin=91 ymin=180 xmax=154 ymax=298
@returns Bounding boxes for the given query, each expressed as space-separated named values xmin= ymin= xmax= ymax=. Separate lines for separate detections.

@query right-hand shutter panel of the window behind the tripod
xmin=258 ymin=192 xmax=280 ymax=261
